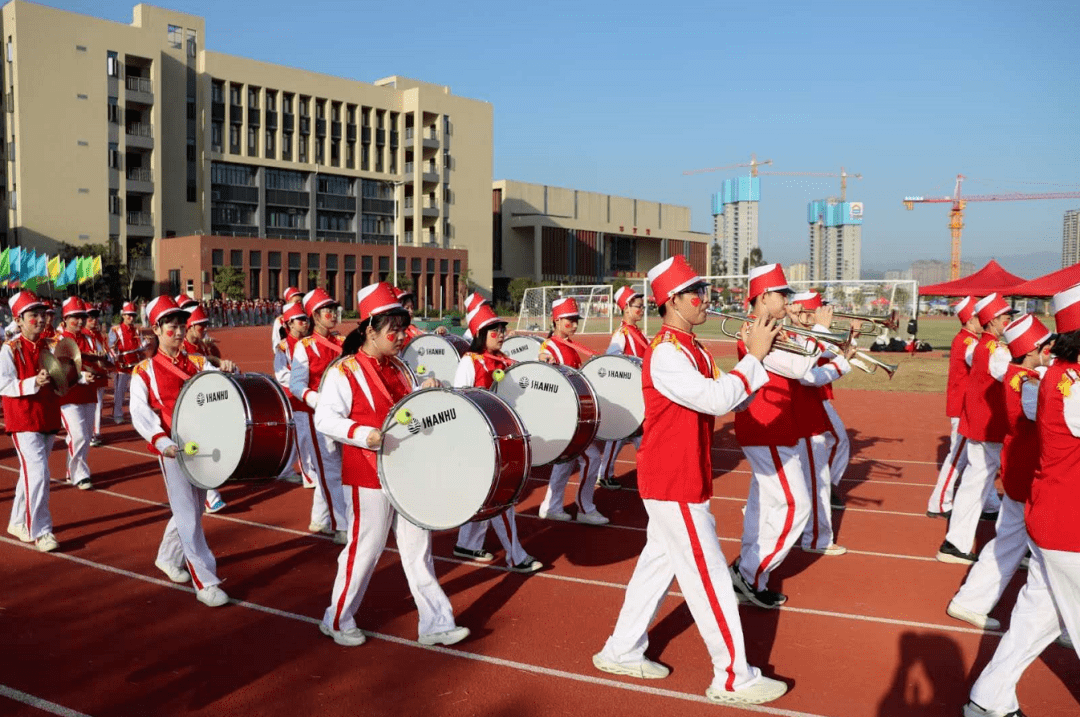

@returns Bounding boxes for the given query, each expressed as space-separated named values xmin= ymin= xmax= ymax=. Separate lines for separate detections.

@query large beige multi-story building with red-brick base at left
xmin=0 ymin=0 xmax=492 ymax=306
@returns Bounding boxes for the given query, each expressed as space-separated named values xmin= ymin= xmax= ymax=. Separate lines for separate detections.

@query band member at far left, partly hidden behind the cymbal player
xmin=53 ymin=296 xmax=97 ymax=490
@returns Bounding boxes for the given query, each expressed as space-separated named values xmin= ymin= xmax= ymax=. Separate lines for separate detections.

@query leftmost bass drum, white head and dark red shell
xmin=173 ymin=371 xmax=296 ymax=489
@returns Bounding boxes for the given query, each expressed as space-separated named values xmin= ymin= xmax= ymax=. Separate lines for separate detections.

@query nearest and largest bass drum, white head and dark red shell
xmin=379 ymin=389 xmax=531 ymax=530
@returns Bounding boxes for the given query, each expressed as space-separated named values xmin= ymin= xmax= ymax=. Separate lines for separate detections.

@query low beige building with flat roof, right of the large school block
xmin=491 ymin=180 xmax=710 ymax=298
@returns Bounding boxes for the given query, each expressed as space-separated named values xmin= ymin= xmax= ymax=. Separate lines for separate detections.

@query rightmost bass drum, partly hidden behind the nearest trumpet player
xmin=581 ymin=353 xmax=645 ymax=441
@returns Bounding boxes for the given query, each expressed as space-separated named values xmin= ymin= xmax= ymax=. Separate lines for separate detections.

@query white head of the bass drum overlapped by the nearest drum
xmin=495 ymin=361 xmax=580 ymax=465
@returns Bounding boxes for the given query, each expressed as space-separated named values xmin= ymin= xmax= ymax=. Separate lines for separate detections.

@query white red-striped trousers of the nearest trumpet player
xmin=602 ymin=499 xmax=761 ymax=691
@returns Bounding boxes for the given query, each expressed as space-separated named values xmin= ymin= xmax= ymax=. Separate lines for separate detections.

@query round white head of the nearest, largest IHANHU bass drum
xmin=379 ymin=389 xmax=498 ymax=530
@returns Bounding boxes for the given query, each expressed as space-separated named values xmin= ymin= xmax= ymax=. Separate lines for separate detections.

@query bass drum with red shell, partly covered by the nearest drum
xmin=495 ymin=361 xmax=599 ymax=465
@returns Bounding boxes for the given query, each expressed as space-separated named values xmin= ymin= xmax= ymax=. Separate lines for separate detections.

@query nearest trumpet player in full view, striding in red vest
xmin=593 ymin=256 xmax=787 ymax=704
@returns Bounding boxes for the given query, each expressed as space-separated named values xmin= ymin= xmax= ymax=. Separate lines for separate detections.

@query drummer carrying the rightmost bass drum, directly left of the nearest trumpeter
xmin=540 ymin=298 xmax=608 ymax=525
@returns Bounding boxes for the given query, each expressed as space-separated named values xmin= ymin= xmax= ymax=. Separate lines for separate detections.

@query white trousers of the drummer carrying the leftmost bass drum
xmin=158 ymin=458 xmax=221 ymax=590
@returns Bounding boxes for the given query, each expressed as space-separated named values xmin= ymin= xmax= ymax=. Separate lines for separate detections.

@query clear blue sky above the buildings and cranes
xmin=46 ymin=0 xmax=1080 ymax=274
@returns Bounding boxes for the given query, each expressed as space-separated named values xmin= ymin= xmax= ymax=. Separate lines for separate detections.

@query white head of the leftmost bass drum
xmin=173 ymin=371 xmax=248 ymax=489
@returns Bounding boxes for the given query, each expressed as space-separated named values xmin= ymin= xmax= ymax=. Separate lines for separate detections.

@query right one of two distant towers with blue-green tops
xmin=807 ymin=199 xmax=863 ymax=281
